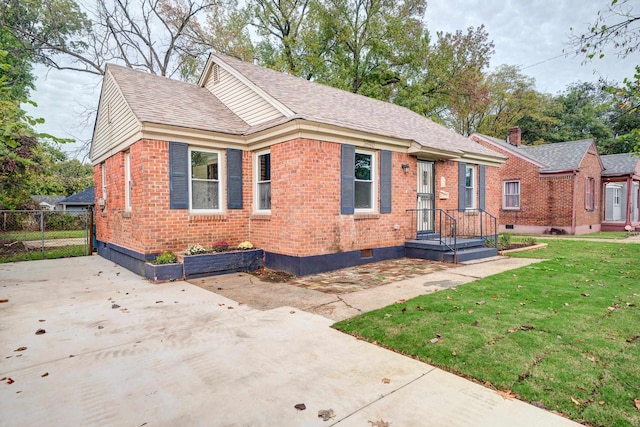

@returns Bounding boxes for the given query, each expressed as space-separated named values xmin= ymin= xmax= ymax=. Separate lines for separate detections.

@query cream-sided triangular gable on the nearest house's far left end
xmin=91 ymin=72 xmax=140 ymax=159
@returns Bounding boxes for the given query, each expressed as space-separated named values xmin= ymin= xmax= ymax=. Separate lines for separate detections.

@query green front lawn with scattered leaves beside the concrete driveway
xmin=334 ymin=240 xmax=640 ymax=427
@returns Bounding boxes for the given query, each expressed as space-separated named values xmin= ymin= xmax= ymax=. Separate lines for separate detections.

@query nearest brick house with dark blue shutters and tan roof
xmin=91 ymin=55 xmax=505 ymax=275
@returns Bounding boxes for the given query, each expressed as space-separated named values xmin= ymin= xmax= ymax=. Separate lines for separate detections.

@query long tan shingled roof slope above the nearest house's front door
xmin=212 ymin=54 xmax=504 ymax=159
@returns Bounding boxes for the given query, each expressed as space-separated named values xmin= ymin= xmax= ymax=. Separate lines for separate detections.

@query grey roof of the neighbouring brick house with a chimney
xmin=474 ymin=133 xmax=595 ymax=173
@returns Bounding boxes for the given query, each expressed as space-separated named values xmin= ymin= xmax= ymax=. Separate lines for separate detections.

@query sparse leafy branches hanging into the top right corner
xmin=570 ymin=0 xmax=640 ymax=59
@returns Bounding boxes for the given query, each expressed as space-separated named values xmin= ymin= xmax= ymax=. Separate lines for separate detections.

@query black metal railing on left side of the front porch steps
xmin=406 ymin=209 xmax=458 ymax=254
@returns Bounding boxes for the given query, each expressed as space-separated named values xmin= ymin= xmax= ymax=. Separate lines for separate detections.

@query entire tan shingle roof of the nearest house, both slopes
xmin=108 ymin=55 xmax=503 ymax=158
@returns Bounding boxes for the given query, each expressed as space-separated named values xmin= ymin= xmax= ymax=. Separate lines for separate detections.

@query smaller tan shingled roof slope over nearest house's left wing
xmin=107 ymin=64 xmax=249 ymax=134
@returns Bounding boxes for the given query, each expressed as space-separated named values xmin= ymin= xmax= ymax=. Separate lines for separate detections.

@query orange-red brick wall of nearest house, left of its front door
xmin=94 ymin=139 xmax=422 ymax=256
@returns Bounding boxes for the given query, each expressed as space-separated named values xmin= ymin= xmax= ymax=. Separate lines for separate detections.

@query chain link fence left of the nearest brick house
xmin=0 ymin=210 xmax=93 ymax=263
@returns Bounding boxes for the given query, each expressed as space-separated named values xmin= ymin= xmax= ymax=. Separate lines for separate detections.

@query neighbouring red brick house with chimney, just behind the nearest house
xmin=470 ymin=128 xmax=603 ymax=234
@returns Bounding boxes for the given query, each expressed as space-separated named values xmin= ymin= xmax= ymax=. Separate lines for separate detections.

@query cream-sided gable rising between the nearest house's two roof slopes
xmin=204 ymin=65 xmax=283 ymax=126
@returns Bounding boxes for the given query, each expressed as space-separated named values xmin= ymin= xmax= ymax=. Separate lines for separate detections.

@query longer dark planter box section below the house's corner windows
xmin=178 ymin=249 xmax=264 ymax=279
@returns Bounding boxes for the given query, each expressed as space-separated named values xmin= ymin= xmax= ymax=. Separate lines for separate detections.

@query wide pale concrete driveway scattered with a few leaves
xmin=0 ymin=256 xmax=577 ymax=427
